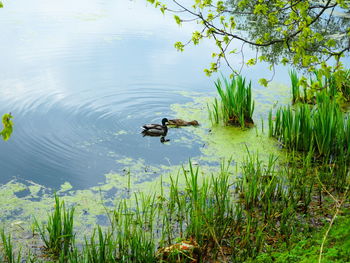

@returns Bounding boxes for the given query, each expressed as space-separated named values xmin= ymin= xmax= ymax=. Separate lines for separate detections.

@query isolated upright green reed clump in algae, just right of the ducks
xmin=208 ymin=75 xmax=254 ymax=128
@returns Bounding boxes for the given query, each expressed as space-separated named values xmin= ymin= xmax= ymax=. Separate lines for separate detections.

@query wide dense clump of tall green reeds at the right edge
xmin=269 ymin=93 xmax=350 ymax=162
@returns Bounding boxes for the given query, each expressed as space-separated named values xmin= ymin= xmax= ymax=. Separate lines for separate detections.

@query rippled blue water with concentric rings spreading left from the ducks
xmin=0 ymin=79 xmax=204 ymax=187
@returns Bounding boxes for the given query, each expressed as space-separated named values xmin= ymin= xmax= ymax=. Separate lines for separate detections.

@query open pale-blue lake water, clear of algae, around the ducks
xmin=0 ymin=0 xmax=288 ymax=189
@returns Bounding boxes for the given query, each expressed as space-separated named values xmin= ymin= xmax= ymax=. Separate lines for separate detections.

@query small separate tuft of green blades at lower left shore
xmin=34 ymin=194 xmax=75 ymax=256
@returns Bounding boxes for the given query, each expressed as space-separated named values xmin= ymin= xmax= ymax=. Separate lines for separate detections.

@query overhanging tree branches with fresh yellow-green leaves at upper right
xmin=147 ymin=0 xmax=350 ymax=84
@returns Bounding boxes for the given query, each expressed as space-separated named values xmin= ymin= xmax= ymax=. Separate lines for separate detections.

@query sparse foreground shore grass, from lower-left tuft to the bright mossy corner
xmin=0 ymin=152 xmax=350 ymax=263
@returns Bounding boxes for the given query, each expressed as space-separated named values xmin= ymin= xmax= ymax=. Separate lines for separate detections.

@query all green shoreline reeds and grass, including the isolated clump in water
xmin=0 ymin=73 xmax=350 ymax=263
